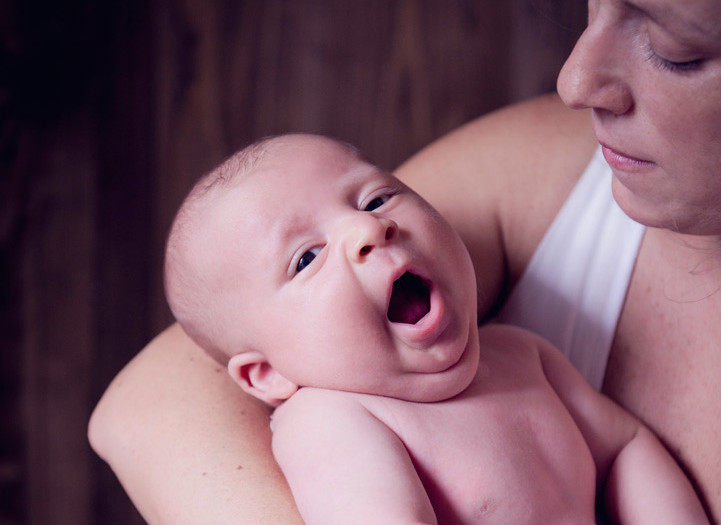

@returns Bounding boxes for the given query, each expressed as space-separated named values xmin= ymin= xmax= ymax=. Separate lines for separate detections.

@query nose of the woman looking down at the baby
xmin=556 ymin=15 xmax=633 ymax=115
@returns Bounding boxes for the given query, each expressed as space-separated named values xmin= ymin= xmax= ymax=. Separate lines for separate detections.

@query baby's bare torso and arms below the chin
xmin=273 ymin=325 xmax=707 ymax=525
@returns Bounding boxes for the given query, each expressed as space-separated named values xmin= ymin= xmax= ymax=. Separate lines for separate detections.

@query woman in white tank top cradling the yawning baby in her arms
xmin=90 ymin=0 xmax=721 ymax=523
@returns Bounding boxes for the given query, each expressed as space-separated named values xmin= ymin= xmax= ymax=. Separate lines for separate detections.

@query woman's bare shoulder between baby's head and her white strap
xmin=396 ymin=94 xmax=597 ymax=312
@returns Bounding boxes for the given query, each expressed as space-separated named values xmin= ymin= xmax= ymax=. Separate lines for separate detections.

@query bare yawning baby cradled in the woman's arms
xmin=166 ymin=135 xmax=707 ymax=525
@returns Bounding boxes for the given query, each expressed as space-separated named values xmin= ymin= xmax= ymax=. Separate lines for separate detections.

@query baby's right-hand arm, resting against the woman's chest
xmin=539 ymin=330 xmax=709 ymax=525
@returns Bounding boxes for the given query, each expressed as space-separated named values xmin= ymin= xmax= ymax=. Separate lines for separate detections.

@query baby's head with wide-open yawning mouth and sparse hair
xmin=166 ymin=135 xmax=478 ymax=405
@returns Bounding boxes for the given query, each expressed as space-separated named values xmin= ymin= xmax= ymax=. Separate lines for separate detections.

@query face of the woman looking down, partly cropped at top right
xmin=558 ymin=0 xmax=721 ymax=234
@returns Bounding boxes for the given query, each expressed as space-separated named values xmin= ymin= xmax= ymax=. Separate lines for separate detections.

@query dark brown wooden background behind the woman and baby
xmin=0 ymin=0 xmax=586 ymax=525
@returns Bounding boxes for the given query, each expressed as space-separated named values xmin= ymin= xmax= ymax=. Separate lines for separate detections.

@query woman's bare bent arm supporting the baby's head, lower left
xmin=88 ymin=325 xmax=302 ymax=525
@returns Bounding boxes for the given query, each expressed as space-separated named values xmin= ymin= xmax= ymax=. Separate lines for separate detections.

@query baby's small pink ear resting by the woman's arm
xmin=228 ymin=351 xmax=298 ymax=406
